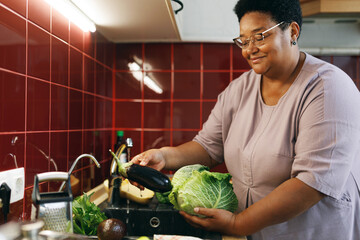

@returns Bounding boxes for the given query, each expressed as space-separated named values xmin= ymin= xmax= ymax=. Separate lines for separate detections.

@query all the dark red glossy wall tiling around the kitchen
xmin=0 ymin=0 xmax=360 ymax=227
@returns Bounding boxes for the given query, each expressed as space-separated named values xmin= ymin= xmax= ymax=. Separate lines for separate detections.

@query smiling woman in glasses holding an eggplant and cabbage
xmin=133 ymin=0 xmax=360 ymax=240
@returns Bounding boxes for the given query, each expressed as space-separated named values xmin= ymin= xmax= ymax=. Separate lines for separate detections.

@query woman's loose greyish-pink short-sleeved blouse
xmin=194 ymin=54 xmax=360 ymax=240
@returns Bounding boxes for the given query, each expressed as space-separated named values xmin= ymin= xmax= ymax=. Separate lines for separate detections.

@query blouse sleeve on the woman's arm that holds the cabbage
xmin=291 ymin=71 xmax=360 ymax=198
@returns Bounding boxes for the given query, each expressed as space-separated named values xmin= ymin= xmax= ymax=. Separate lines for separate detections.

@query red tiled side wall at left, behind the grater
xmin=0 ymin=0 xmax=114 ymax=220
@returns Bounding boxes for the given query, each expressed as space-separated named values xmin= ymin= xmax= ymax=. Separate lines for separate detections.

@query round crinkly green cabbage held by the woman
xmin=169 ymin=164 xmax=238 ymax=217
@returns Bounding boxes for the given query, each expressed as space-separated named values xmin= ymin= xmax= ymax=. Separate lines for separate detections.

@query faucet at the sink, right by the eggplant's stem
xmin=109 ymin=138 xmax=133 ymax=206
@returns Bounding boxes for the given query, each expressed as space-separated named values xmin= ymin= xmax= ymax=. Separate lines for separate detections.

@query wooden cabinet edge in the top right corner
xmin=300 ymin=0 xmax=360 ymax=17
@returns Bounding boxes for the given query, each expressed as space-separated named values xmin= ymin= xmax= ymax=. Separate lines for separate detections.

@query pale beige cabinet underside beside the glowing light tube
xmin=72 ymin=0 xmax=180 ymax=43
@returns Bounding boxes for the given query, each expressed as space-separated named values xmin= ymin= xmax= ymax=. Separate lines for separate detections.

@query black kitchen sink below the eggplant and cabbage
xmin=99 ymin=197 xmax=222 ymax=240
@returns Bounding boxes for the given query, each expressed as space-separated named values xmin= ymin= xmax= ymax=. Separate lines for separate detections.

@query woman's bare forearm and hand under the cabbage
xmin=180 ymin=178 xmax=323 ymax=236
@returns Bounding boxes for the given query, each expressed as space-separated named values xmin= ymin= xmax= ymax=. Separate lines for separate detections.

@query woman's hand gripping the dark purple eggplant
xmin=131 ymin=149 xmax=166 ymax=171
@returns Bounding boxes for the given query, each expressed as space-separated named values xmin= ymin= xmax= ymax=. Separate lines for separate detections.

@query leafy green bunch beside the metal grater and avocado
xmin=72 ymin=193 xmax=107 ymax=236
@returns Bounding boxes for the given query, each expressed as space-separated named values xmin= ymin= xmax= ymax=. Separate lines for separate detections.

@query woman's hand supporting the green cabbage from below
xmin=180 ymin=208 xmax=236 ymax=233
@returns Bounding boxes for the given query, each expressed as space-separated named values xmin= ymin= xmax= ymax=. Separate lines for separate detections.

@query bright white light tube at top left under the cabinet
xmin=45 ymin=0 xmax=96 ymax=32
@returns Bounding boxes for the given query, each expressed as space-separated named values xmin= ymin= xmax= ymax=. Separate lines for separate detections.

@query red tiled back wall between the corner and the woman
xmin=114 ymin=43 xmax=249 ymax=171
